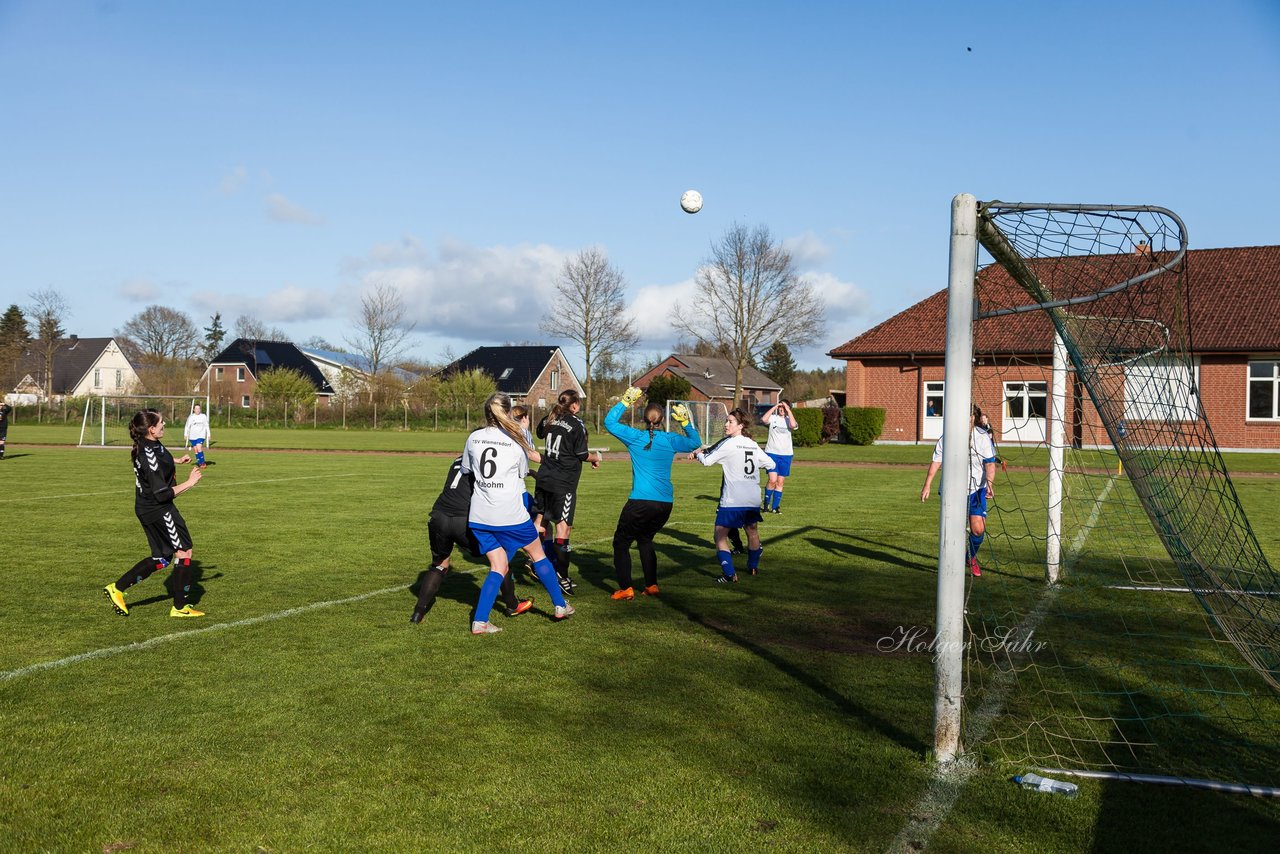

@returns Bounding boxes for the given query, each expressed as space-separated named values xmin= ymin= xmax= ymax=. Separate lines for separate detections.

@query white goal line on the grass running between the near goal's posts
xmin=886 ymin=475 xmax=1116 ymax=854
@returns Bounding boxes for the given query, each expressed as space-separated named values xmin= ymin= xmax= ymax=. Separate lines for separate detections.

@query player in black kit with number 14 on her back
xmin=538 ymin=389 xmax=600 ymax=593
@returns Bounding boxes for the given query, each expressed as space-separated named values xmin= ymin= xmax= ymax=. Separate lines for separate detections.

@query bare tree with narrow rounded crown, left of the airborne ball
xmin=541 ymin=247 xmax=639 ymax=401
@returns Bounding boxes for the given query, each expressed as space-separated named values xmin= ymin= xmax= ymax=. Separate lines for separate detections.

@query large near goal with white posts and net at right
xmin=934 ymin=197 xmax=1280 ymax=795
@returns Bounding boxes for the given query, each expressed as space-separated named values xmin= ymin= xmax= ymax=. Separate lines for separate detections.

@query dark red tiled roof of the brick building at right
xmin=827 ymin=246 xmax=1280 ymax=359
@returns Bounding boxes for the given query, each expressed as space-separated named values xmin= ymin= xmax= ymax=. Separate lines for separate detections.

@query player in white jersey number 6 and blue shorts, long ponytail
xmin=461 ymin=392 xmax=573 ymax=635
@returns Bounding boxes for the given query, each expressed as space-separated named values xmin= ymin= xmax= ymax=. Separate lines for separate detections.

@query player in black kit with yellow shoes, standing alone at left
xmin=104 ymin=410 xmax=205 ymax=617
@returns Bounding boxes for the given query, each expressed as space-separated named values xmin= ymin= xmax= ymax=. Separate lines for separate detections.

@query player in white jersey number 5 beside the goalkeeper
xmin=690 ymin=408 xmax=777 ymax=584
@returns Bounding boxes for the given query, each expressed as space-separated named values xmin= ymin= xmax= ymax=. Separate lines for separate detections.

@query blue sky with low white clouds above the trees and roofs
xmin=0 ymin=0 xmax=1280 ymax=367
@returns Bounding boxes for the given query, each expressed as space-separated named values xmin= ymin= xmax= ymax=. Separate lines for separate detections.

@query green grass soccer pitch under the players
xmin=0 ymin=435 xmax=1280 ymax=853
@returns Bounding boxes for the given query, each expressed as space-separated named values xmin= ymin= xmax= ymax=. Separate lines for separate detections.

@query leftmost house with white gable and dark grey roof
xmin=13 ymin=335 xmax=140 ymax=402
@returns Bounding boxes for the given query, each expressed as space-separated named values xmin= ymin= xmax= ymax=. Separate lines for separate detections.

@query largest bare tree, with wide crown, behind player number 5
xmin=672 ymin=223 xmax=826 ymax=401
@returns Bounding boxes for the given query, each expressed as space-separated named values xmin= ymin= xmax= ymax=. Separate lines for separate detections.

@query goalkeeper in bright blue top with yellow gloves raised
xmin=604 ymin=387 xmax=703 ymax=599
